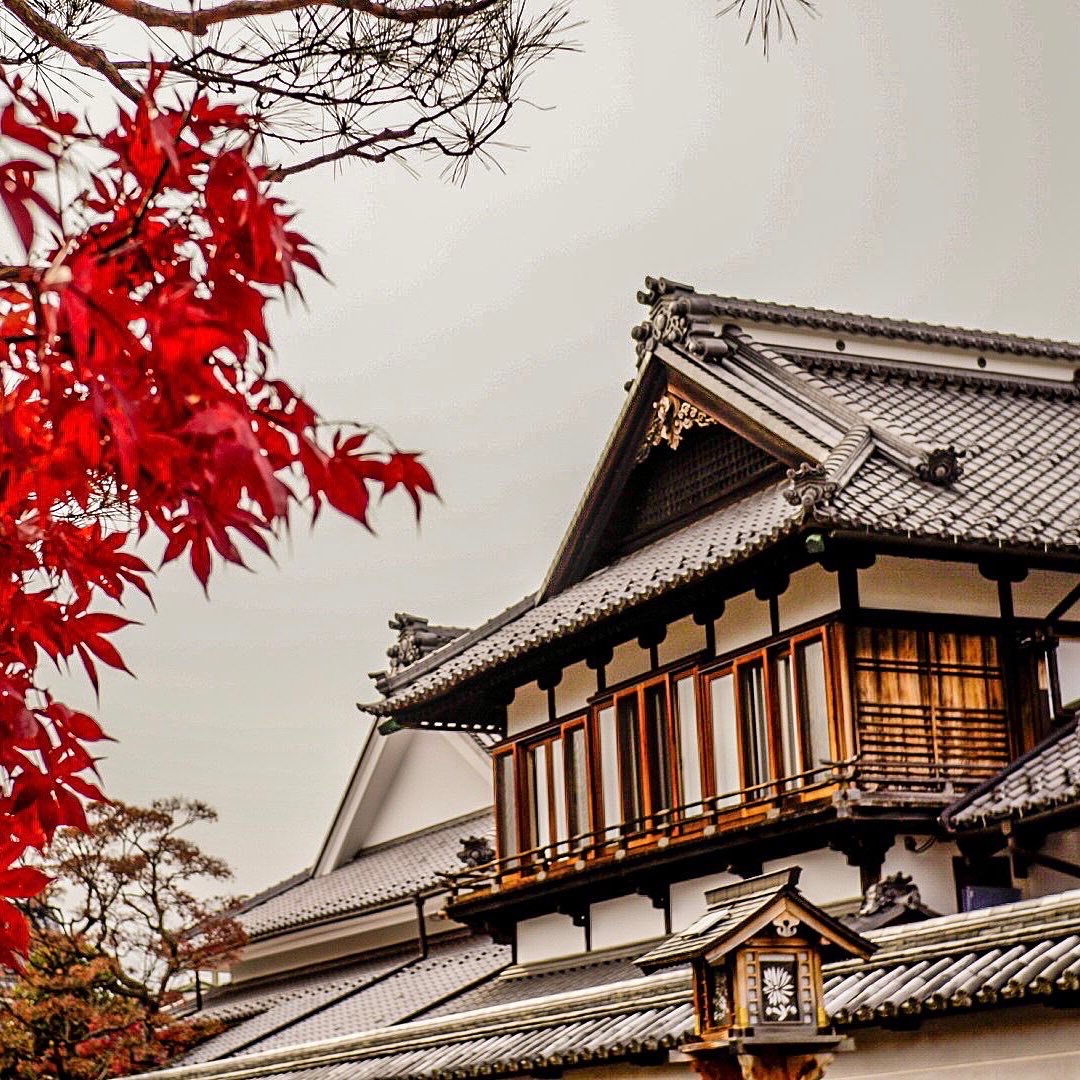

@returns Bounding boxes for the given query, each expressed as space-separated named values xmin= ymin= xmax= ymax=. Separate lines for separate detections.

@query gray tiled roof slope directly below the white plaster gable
xmin=240 ymin=810 xmax=495 ymax=937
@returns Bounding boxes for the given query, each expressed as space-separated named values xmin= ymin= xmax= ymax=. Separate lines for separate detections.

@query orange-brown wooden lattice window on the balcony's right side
xmin=854 ymin=626 xmax=1011 ymax=783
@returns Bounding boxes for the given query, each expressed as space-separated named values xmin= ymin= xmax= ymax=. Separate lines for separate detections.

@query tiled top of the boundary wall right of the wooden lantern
xmin=824 ymin=890 xmax=1080 ymax=1026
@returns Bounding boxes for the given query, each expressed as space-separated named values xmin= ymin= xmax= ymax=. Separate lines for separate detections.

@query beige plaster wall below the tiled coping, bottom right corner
xmin=825 ymin=1005 xmax=1080 ymax=1080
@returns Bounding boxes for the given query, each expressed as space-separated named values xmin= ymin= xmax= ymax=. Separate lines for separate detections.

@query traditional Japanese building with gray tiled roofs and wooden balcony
xmin=130 ymin=279 xmax=1080 ymax=1080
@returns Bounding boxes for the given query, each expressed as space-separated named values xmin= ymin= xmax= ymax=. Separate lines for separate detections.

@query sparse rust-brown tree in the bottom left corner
xmin=0 ymin=798 xmax=244 ymax=1080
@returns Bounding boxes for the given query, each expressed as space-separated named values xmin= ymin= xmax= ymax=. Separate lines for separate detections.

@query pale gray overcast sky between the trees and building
xmin=65 ymin=0 xmax=1080 ymax=891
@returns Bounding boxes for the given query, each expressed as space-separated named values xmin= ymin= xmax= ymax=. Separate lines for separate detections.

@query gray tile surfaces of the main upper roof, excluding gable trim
xmin=365 ymin=304 xmax=1080 ymax=715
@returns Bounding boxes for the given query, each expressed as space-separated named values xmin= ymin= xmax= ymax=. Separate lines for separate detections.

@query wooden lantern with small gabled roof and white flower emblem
xmin=637 ymin=866 xmax=875 ymax=1080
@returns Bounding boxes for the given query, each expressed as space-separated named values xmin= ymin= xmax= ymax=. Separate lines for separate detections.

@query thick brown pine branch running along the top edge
xmin=96 ymin=0 xmax=505 ymax=37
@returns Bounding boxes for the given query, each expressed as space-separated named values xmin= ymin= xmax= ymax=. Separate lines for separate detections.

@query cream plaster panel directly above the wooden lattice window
xmin=859 ymin=555 xmax=1000 ymax=618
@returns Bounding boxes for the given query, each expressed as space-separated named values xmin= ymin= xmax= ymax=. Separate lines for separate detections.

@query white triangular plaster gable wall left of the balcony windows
xmin=362 ymin=730 xmax=491 ymax=848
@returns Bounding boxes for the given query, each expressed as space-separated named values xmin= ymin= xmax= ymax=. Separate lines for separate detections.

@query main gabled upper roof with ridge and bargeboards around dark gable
xmin=362 ymin=282 xmax=1080 ymax=715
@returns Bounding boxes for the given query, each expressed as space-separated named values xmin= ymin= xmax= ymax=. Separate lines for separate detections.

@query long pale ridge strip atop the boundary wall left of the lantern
xmin=120 ymin=971 xmax=690 ymax=1080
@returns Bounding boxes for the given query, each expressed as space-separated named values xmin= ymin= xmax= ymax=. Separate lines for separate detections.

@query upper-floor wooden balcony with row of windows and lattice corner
xmin=451 ymin=620 xmax=1028 ymax=902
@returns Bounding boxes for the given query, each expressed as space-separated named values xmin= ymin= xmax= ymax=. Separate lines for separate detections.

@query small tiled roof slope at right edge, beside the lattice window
xmin=942 ymin=720 xmax=1080 ymax=829
